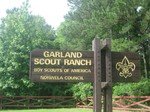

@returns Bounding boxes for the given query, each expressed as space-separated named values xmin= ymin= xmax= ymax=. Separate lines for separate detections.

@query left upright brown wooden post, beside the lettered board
xmin=92 ymin=38 xmax=101 ymax=112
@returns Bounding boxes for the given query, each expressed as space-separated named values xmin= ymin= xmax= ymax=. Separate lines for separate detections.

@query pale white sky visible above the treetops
xmin=0 ymin=0 xmax=69 ymax=29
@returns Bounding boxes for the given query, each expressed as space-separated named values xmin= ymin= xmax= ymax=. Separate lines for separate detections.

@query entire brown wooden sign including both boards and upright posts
xmin=29 ymin=38 xmax=140 ymax=112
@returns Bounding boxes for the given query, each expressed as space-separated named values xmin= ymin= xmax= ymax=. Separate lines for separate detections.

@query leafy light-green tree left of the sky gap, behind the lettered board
xmin=0 ymin=2 xmax=56 ymax=95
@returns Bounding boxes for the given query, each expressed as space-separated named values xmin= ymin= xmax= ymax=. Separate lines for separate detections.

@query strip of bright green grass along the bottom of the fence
xmin=0 ymin=108 xmax=129 ymax=112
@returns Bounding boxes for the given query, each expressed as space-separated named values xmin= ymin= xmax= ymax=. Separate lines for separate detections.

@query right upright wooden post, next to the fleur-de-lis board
xmin=103 ymin=38 xmax=112 ymax=112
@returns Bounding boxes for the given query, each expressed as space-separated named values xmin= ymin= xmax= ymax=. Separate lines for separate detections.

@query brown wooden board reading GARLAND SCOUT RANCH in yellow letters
xmin=30 ymin=49 xmax=94 ymax=82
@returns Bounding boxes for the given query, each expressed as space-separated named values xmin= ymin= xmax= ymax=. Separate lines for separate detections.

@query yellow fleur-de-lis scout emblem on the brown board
xmin=116 ymin=56 xmax=135 ymax=78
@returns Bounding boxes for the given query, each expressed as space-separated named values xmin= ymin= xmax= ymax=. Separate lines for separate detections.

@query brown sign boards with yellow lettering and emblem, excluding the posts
xmin=30 ymin=49 xmax=141 ymax=82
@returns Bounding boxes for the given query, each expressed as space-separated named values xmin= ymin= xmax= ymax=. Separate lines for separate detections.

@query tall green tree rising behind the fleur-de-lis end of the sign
xmin=58 ymin=0 xmax=150 ymax=98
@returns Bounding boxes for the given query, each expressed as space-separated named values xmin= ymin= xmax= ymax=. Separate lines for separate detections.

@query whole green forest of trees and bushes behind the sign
xmin=0 ymin=0 xmax=150 ymax=99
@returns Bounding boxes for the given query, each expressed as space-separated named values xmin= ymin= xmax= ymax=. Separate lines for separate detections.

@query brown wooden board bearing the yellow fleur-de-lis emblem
xmin=112 ymin=52 xmax=141 ymax=82
